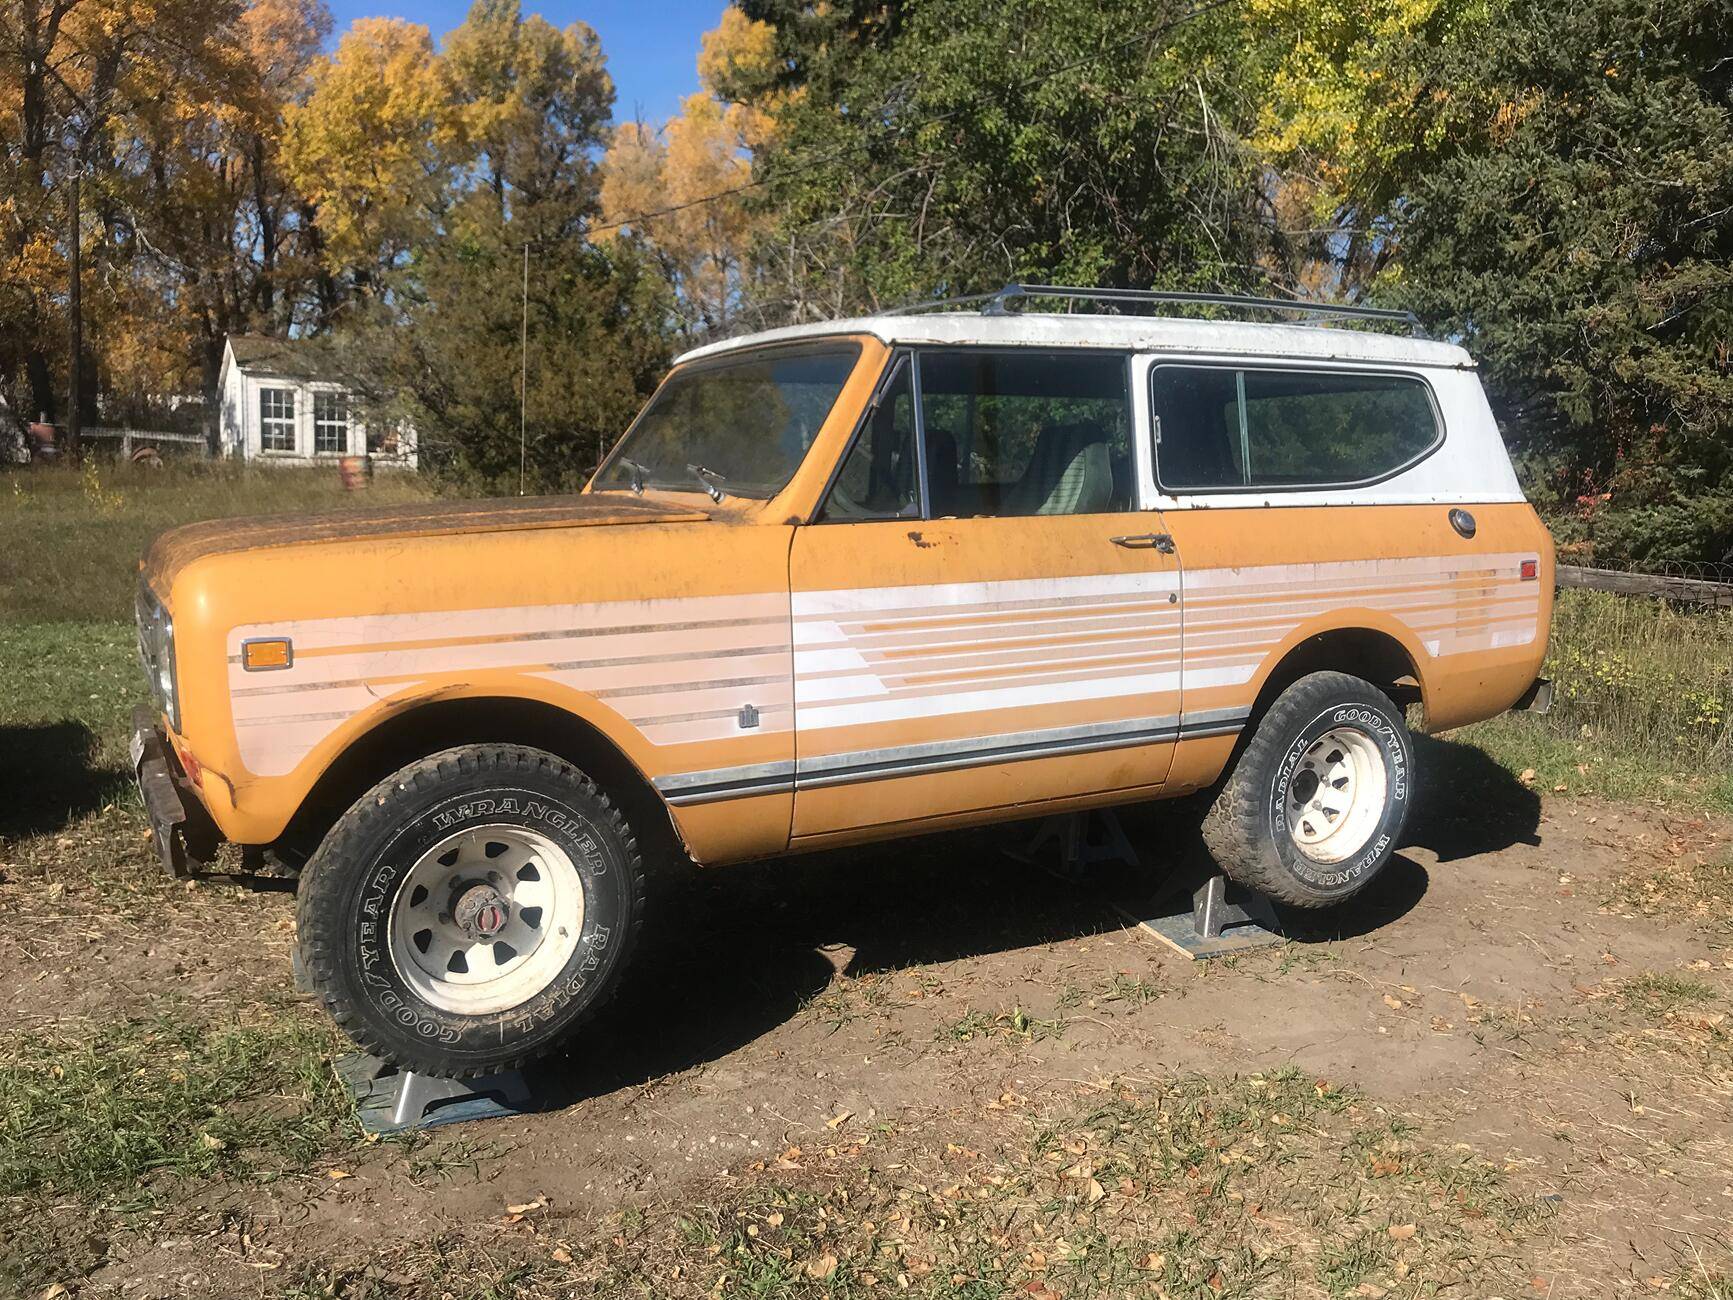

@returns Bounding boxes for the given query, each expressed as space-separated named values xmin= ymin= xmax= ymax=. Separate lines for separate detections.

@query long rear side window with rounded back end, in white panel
xmin=1152 ymin=366 xmax=1440 ymax=492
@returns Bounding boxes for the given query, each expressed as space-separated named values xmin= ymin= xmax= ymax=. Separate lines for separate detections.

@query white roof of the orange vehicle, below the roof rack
xmin=676 ymin=310 xmax=1475 ymax=367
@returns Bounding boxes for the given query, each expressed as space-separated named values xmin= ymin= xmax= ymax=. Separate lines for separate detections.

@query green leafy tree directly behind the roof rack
xmin=727 ymin=0 xmax=1288 ymax=317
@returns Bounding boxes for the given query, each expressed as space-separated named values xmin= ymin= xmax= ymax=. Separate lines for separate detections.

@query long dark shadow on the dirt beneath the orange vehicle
xmin=530 ymin=790 xmax=1428 ymax=1109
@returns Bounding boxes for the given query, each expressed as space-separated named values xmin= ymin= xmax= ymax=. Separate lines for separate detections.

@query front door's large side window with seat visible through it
xmin=920 ymin=350 xmax=1132 ymax=518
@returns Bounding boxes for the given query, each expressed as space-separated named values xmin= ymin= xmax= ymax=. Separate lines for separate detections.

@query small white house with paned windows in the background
xmin=217 ymin=335 xmax=416 ymax=468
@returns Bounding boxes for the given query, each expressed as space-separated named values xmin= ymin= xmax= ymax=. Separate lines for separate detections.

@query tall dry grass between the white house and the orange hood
xmin=0 ymin=461 xmax=430 ymax=622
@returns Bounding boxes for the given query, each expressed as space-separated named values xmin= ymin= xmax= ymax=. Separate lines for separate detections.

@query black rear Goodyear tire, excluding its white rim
xmin=1203 ymin=673 xmax=1414 ymax=908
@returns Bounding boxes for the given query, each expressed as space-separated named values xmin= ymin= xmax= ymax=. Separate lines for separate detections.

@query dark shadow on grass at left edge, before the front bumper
xmin=0 ymin=721 xmax=130 ymax=839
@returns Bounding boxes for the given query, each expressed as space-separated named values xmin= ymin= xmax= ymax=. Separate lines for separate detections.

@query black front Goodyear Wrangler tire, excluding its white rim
xmin=296 ymin=745 xmax=645 ymax=1078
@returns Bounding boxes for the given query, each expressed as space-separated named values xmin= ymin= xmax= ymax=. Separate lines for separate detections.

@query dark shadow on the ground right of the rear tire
xmin=1402 ymin=735 xmax=1541 ymax=861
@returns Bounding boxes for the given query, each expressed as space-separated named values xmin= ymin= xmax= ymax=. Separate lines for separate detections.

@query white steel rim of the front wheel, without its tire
xmin=390 ymin=825 xmax=584 ymax=1016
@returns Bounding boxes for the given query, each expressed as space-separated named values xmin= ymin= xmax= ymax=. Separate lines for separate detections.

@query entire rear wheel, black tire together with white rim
xmin=1204 ymin=673 xmax=1414 ymax=907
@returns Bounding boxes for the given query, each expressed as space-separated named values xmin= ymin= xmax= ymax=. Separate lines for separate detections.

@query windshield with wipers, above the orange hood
xmin=594 ymin=343 xmax=860 ymax=497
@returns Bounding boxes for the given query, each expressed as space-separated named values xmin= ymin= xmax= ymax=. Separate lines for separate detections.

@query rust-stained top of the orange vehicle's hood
xmin=140 ymin=492 xmax=711 ymax=593
